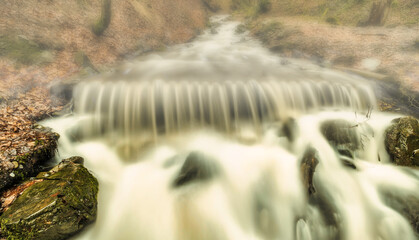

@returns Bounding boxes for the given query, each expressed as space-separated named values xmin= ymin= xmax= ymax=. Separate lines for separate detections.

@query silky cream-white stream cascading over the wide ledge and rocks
xmin=45 ymin=16 xmax=419 ymax=240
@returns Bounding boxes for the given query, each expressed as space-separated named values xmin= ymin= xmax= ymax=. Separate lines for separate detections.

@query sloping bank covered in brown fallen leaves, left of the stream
xmin=0 ymin=0 xmax=207 ymax=191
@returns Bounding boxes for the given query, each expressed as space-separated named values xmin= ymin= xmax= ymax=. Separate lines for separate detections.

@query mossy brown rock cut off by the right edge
xmin=385 ymin=117 xmax=419 ymax=166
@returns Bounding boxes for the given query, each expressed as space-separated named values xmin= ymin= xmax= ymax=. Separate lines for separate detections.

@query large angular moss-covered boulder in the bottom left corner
xmin=0 ymin=157 xmax=98 ymax=240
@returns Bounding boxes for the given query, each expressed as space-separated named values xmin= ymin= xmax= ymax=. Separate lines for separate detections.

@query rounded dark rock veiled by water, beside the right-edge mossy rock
xmin=320 ymin=119 xmax=361 ymax=151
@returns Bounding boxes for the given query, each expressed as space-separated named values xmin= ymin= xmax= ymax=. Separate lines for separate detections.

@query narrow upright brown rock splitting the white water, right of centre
xmin=300 ymin=147 xmax=319 ymax=195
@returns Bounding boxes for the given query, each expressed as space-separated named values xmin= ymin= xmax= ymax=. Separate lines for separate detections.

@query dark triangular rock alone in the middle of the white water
xmin=173 ymin=152 xmax=218 ymax=188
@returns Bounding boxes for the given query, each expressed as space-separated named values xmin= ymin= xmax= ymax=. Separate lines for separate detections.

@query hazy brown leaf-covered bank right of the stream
xmin=247 ymin=15 xmax=419 ymax=114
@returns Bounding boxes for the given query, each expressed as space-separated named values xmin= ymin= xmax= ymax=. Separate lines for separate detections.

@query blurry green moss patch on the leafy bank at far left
xmin=0 ymin=36 xmax=53 ymax=65
